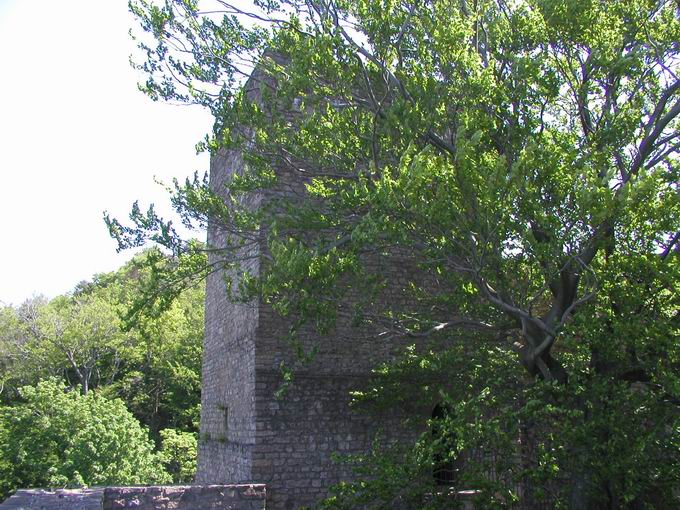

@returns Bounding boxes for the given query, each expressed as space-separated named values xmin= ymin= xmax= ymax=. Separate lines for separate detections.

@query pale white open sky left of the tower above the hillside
xmin=0 ymin=0 xmax=211 ymax=304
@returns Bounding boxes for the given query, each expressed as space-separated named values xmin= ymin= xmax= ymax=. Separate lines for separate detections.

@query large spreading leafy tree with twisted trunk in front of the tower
xmin=113 ymin=0 xmax=680 ymax=508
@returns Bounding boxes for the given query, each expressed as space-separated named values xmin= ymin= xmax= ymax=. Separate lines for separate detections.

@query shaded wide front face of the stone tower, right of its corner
xmin=252 ymin=255 xmax=429 ymax=510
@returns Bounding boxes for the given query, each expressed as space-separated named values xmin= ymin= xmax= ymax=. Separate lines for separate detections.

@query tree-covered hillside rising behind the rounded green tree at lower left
xmin=0 ymin=251 xmax=205 ymax=438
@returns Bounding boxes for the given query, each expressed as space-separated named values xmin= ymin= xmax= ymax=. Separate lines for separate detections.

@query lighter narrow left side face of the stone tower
xmin=196 ymin=146 xmax=259 ymax=483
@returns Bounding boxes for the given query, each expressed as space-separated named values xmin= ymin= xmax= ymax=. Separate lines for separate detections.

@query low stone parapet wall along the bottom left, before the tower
xmin=0 ymin=484 xmax=267 ymax=510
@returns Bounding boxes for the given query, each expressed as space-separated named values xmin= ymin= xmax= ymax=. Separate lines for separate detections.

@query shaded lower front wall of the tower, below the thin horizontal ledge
xmin=252 ymin=372 xmax=412 ymax=510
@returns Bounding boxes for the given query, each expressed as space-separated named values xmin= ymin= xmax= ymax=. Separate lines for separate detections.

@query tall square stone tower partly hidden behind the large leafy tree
xmin=196 ymin=68 xmax=412 ymax=509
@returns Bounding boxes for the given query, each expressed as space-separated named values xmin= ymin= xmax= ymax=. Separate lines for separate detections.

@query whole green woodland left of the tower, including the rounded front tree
xmin=0 ymin=250 xmax=205 ymax=500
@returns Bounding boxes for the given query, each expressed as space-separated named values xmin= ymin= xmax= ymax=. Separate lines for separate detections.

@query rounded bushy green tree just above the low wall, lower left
xmin=0 ymin=379 xmax=169 ymax=497
